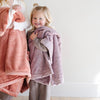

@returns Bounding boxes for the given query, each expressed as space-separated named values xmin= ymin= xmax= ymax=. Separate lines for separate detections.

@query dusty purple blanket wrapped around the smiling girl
xmin=28 ymin=26 xmax=63 ymax=85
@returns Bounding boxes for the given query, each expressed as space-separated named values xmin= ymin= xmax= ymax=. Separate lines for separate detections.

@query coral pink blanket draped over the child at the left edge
xmin=0 ymin=7 xmax=30 ymax=96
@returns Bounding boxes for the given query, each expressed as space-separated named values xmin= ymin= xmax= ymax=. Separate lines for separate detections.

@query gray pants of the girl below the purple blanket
xmin=29 ymin=80 xmax=50 ymax=100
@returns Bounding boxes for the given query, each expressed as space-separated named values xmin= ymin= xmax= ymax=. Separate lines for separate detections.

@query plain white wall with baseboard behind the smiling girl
xmin=20 ymin=0 xmax=100 ymax=97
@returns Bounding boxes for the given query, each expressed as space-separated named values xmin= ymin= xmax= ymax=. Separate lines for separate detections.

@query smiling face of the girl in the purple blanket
xmin=32 ymin=11 xmax=46 ymax=28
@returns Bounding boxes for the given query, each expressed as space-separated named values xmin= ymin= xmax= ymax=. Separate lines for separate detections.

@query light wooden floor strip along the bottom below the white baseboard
xmin=12 ymin=96 xmax=100 ymax=100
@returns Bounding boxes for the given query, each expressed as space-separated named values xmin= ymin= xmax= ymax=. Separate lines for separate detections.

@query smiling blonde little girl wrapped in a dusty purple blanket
xmin=27 ymin=4 xmax=63 ymax=100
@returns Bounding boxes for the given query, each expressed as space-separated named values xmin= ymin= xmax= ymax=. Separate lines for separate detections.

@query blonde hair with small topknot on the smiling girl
xmin=30 ymin=3 xmax=52 ymax=29
